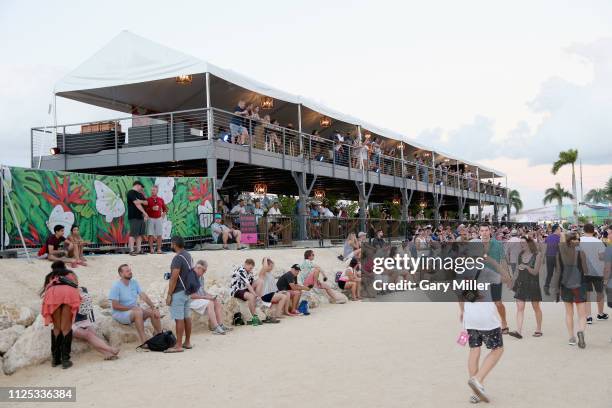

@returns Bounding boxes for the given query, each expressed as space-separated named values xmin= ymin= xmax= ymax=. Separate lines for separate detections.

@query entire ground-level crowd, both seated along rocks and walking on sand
xmin=41 ymin=212 xmax=612 ymax=403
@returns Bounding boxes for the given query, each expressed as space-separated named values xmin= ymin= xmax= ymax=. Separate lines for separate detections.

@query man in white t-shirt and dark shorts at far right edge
xmin=580 ymin=224 xmax=608 ymax=324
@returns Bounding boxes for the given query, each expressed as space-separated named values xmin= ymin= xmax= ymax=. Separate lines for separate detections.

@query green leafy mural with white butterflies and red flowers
xmin=2 ymin=167 xmax=213 ymax=246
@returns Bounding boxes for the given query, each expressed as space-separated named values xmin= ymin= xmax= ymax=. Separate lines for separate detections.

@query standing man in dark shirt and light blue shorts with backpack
xmin=164 ymin=236 xmax=199 ymax=353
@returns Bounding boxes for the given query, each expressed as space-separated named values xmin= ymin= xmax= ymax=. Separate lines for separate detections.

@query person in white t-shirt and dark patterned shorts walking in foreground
xmin=459 ymin=270 xmax=504 ymax=403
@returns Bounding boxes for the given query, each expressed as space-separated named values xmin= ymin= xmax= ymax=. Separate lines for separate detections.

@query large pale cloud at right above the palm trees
xmin=418 ymin=38 xmax=612 ymax=165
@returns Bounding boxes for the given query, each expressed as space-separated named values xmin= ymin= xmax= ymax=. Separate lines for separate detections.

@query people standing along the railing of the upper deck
xmin=215 ymin=99 xmax=505 ymax=196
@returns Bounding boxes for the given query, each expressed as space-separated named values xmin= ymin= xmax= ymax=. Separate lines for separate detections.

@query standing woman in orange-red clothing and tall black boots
xmin=40 ymin=261 xmax=81 ymax=368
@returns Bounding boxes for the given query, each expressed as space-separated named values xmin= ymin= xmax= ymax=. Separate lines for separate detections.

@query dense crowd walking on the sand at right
xmin=358 ymin=224 xmax=612 ymax=403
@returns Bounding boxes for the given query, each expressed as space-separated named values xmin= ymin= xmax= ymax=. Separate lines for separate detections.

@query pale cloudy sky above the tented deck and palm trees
xmin=0 ymin=0 xmax=612 ymax=208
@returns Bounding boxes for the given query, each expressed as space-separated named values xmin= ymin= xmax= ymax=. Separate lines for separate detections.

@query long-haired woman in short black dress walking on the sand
xmin=508 ymin=237 xmax=542 ymax=339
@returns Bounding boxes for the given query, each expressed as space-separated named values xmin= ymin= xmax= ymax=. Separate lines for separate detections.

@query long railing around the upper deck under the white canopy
xmin=31 ymin=108 xmax=507 ymax=197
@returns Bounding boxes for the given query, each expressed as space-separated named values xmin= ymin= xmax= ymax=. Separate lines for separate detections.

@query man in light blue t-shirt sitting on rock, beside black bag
xmin=108 ymin=264 xmax=161 ymax=344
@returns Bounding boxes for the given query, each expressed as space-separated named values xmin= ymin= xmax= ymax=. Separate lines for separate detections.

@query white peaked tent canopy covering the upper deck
xmin=54 ymin=31 xmax=503 ymax=177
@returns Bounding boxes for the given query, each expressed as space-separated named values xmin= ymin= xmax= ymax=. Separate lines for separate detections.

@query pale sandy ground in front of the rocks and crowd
xmin=0 ymin=250 xmax=612 ymax=408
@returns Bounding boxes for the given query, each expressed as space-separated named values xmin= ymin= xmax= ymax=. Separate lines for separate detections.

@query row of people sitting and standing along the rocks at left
xmin=41 ymin=236 xmax=360 ymax=368
